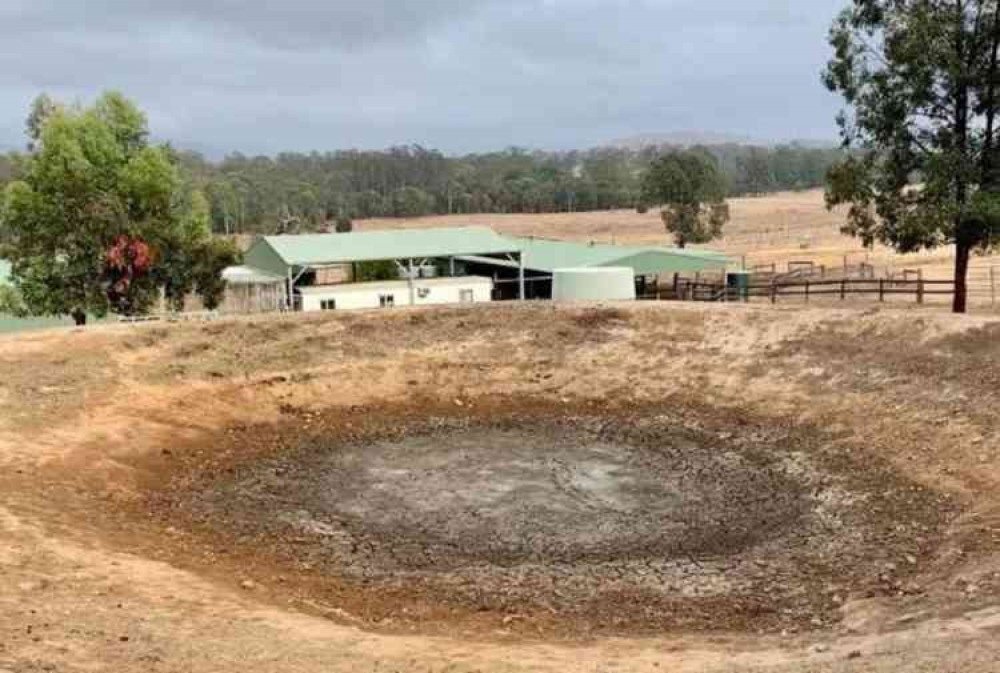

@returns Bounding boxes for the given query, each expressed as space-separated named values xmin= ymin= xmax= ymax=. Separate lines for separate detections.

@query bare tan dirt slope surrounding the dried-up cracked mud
xmin=0 ymin=305 xmax=1000 ymax=673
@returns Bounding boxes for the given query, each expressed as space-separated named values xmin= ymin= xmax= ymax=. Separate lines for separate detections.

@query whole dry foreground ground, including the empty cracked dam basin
xmin=0 ymin=304 xmax=1000 ymax=673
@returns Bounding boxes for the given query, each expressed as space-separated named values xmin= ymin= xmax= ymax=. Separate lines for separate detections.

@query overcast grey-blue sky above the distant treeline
xmin=0 ymin=0 xmax=847 ymax=155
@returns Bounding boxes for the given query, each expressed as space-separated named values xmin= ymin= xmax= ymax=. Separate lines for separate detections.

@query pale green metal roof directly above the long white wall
xmin=263 ymin=227 xmax=520 ymax=267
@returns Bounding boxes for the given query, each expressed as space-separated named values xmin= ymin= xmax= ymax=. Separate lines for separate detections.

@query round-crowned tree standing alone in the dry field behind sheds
xmin=641 ymin=150 xmax=729 ymax=248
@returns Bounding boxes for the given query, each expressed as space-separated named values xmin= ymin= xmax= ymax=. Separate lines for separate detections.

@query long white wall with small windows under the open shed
xmin=302 ymin=278 xmax=493 ymax=311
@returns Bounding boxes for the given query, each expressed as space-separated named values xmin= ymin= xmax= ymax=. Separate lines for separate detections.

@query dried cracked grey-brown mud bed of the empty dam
xmin=146 ymin=407 xmax=953 ymax=632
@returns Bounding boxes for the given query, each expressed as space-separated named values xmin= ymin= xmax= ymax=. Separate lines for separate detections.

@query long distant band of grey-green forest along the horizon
xmin=0 ymin=145 xmax=841 ymax=233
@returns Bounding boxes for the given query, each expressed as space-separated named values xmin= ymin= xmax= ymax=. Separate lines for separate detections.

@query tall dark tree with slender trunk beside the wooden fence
xmin=824 ymin=0 xmax=1000 ymax=313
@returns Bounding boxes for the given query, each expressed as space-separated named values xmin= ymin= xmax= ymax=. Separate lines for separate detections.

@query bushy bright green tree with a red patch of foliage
xmin=0 ymin=93 xmax=231 ymax=324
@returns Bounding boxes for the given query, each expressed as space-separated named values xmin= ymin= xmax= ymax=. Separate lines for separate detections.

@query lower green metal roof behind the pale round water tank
xmin=482 ymin=238 xmax=729 ymax=275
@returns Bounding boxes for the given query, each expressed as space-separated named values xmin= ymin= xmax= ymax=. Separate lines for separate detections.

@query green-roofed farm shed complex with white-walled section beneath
xmin=234 ymin=227 xmax=728 ymax=310
